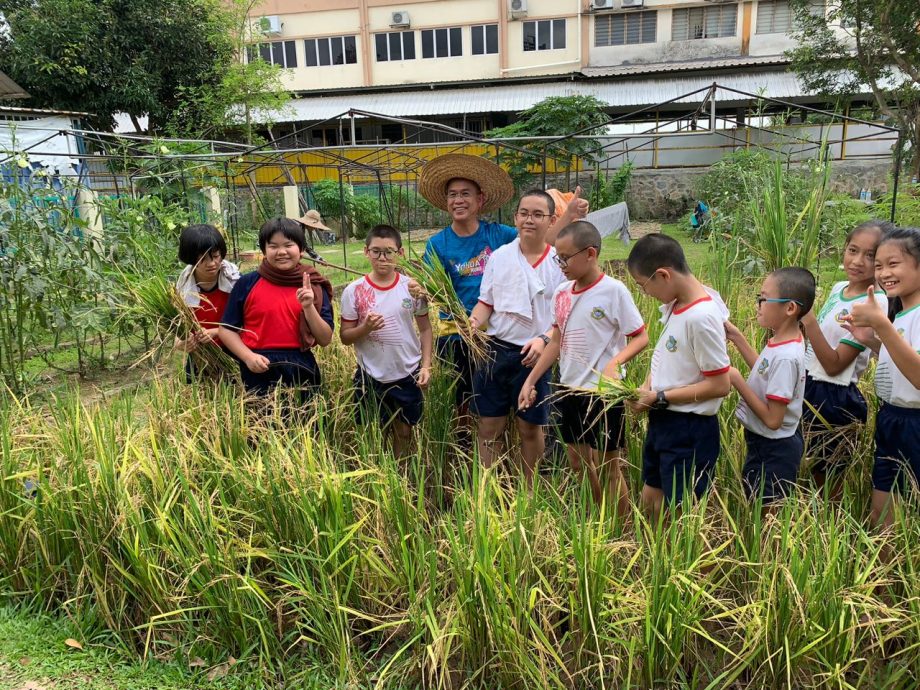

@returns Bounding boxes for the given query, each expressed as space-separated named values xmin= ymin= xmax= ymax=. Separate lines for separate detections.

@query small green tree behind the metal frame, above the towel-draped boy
xmin=485 ymin=96 xmax=609 ymax=186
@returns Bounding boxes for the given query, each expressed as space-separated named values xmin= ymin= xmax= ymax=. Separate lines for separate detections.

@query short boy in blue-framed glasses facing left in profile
xmin=725 ymin=267 xmax=815 ymax=505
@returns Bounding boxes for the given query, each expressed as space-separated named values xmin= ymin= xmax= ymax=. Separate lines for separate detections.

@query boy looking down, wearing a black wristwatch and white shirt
xmin=626 ymin=233 xmax=731 ymax=517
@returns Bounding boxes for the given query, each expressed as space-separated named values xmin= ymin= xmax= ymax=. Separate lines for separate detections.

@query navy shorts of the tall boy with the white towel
xmin=470 ymin=338 xmax=549 ymax=426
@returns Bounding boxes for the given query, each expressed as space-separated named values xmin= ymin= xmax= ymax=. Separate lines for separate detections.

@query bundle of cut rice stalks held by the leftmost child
xmin=122 ymin=276 xmax=239 ymax=377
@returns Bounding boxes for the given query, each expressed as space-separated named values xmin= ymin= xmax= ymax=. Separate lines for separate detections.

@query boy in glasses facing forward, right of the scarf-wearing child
xmin=339 ymin=225 xmax=433 ymax=457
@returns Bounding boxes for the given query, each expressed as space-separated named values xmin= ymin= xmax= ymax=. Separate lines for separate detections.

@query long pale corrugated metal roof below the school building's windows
xmin=276 ymin=71 xmax=807 ymax=122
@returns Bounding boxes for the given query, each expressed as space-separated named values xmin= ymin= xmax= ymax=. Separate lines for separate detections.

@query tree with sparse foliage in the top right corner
xmin=788 ymin=0 xmax=920 ymax=175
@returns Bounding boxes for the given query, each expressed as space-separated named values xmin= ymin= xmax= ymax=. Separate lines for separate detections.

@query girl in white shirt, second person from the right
xmin=802 ymin=220 xmax=894 ymax=500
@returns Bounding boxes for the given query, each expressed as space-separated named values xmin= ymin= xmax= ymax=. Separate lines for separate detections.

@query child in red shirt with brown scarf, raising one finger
xmin=220 ymin=218 xmax=333 ymax=401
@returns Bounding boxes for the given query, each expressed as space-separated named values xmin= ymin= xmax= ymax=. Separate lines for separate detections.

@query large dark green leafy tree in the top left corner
xmin=0 ymin=0 xmax=288 ymax=134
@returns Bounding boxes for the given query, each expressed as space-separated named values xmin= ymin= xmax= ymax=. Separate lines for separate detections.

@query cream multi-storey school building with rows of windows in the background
xmin=243 ymin=0 xmax=848 ymax=147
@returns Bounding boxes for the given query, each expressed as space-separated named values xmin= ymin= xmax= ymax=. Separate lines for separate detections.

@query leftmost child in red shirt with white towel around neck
xmin=176 ymin=225 xmax=240 ymax=379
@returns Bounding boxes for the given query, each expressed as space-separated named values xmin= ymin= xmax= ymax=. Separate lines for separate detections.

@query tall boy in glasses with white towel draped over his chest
xmin=470 ymin=189 xmax=565 ymax=484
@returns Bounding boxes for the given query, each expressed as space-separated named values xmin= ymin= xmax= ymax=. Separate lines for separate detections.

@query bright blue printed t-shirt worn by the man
xmin=425 ymin=220 xmax=517 ymax=319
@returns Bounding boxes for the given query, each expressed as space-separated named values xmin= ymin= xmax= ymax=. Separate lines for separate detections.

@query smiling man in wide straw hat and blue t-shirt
xmin=419 ymin=153 xmax=588 ymax=416
